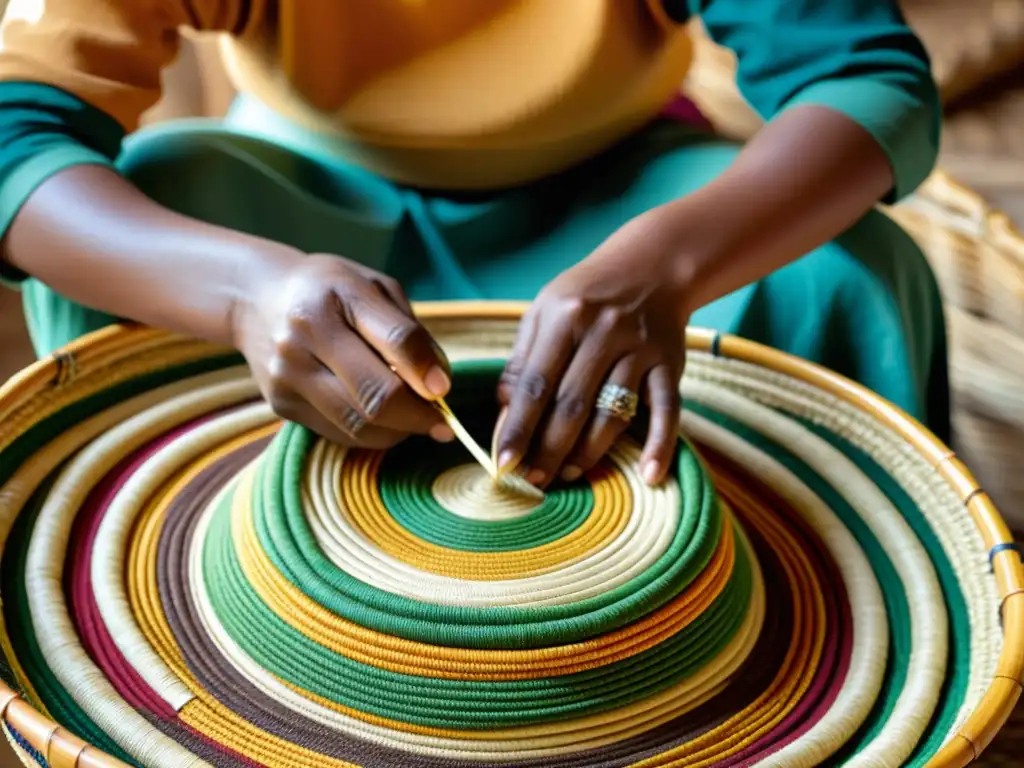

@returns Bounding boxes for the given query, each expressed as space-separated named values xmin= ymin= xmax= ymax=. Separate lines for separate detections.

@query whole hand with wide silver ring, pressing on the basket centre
xmin=497 ymin=212 xmax=689 ymax=487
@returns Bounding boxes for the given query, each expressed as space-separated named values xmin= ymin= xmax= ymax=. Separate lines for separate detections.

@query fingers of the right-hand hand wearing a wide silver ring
xmin=495 ymin=304 xmax=683 ymax=487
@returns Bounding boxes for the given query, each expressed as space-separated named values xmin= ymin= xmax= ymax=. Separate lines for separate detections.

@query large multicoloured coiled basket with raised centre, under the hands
xmin=0 ymin=304 xmax=1024 ymax=768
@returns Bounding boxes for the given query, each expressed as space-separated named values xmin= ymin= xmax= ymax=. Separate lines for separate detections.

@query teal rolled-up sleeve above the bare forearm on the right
xmin=684 ymin=0 xmax=942 ymax=203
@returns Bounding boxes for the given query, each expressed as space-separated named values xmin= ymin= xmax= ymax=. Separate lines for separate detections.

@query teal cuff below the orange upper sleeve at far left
xmin=0 ymin=82 xmax=125 ymax=285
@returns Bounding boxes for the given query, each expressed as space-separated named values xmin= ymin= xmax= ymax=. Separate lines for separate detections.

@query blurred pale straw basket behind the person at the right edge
xmin=890 ymin=172 xmax=1024 ymax=532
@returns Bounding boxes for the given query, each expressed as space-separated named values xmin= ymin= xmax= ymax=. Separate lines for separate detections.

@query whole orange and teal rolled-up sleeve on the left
xmin=0 ymin=0 xmax=254 ymax=283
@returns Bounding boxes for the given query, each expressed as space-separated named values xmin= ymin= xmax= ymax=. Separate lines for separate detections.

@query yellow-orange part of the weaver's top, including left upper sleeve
xmin=0 ymin=0 xmax=690 ymax=188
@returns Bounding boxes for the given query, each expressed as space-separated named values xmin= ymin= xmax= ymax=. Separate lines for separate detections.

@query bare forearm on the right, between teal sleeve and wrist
xmin=655 ymin=105 xmax=894 ymax=312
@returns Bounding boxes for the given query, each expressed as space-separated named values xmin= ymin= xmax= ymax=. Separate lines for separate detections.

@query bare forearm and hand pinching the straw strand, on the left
xmin=5 ymin=166 xmax=454 ymax=449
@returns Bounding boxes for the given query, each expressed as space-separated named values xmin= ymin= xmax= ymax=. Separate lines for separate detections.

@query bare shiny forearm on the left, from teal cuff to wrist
xmin=3 ymin=165 xmax=301 ymax=344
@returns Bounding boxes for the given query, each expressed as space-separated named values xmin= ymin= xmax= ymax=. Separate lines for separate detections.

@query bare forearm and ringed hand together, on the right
xmin=498 ymin=106 xmax=894 ymax=486
